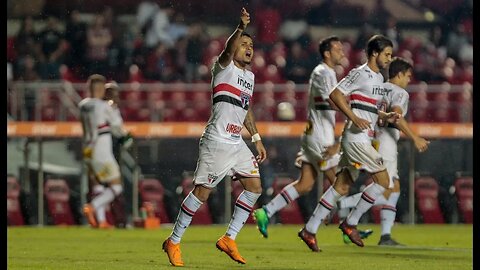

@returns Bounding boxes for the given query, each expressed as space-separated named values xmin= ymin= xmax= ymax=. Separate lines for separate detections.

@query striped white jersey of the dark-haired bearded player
xmin=332 ymin=63 xmax=385 ymax=143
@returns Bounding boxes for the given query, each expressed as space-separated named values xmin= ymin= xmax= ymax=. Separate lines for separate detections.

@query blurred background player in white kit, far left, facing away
xmin=78 ymin=74 xmax=128 ymax=228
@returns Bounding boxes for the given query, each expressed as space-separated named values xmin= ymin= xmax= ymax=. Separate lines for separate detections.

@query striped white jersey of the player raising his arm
xmin=202 ymin=61 xmax=255 ymax=144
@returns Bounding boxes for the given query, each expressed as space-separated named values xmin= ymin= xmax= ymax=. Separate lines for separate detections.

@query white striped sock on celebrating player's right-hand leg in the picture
xmin=226 ymin=190 xmax=261 ymax=240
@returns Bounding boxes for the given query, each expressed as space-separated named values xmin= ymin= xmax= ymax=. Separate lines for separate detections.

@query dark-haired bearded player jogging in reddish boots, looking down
xmin=299 ymin=35 xmax=399 ymax=250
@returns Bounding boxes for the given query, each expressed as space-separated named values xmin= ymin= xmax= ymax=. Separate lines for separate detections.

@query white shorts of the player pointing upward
xmin=193 ymin=138 xmax=260 ymax=188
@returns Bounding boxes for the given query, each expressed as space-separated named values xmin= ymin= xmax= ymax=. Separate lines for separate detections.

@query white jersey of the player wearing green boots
xmin=302 ymin=63 xmax=337 ymax=146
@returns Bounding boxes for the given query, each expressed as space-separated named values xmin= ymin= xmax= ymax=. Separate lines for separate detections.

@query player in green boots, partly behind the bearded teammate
xmin=253 ymin=36 xmax=345 ymax=240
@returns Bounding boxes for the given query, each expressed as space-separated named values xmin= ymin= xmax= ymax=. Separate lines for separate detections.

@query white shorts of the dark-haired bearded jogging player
xmin=337 ymin=141 xmax=385 ymax=182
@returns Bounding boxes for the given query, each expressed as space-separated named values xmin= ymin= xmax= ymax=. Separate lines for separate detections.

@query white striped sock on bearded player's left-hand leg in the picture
xmin=305 ymin=186 xmax=341 ymax=234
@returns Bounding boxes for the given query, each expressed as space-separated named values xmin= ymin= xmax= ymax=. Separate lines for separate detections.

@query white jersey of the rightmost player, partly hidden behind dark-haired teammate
xmin=375 ymin=82 xmax=409 ymax=161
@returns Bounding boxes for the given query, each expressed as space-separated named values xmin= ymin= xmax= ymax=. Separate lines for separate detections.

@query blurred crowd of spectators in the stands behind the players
xmin=7 ymin=0 xmax=473 ymax=122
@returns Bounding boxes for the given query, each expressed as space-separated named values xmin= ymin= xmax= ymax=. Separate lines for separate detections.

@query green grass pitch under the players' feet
xmin=7 ymin=224 xmax=473 ymax=270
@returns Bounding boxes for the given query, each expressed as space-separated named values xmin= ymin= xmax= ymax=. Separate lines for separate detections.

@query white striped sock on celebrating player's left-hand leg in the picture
xmin=170 ymin=192 xmax=203 ymax=244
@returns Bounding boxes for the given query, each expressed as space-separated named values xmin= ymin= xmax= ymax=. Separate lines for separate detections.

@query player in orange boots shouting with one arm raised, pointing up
xmin=163 ymin=8 xmax=267 ymax=266
